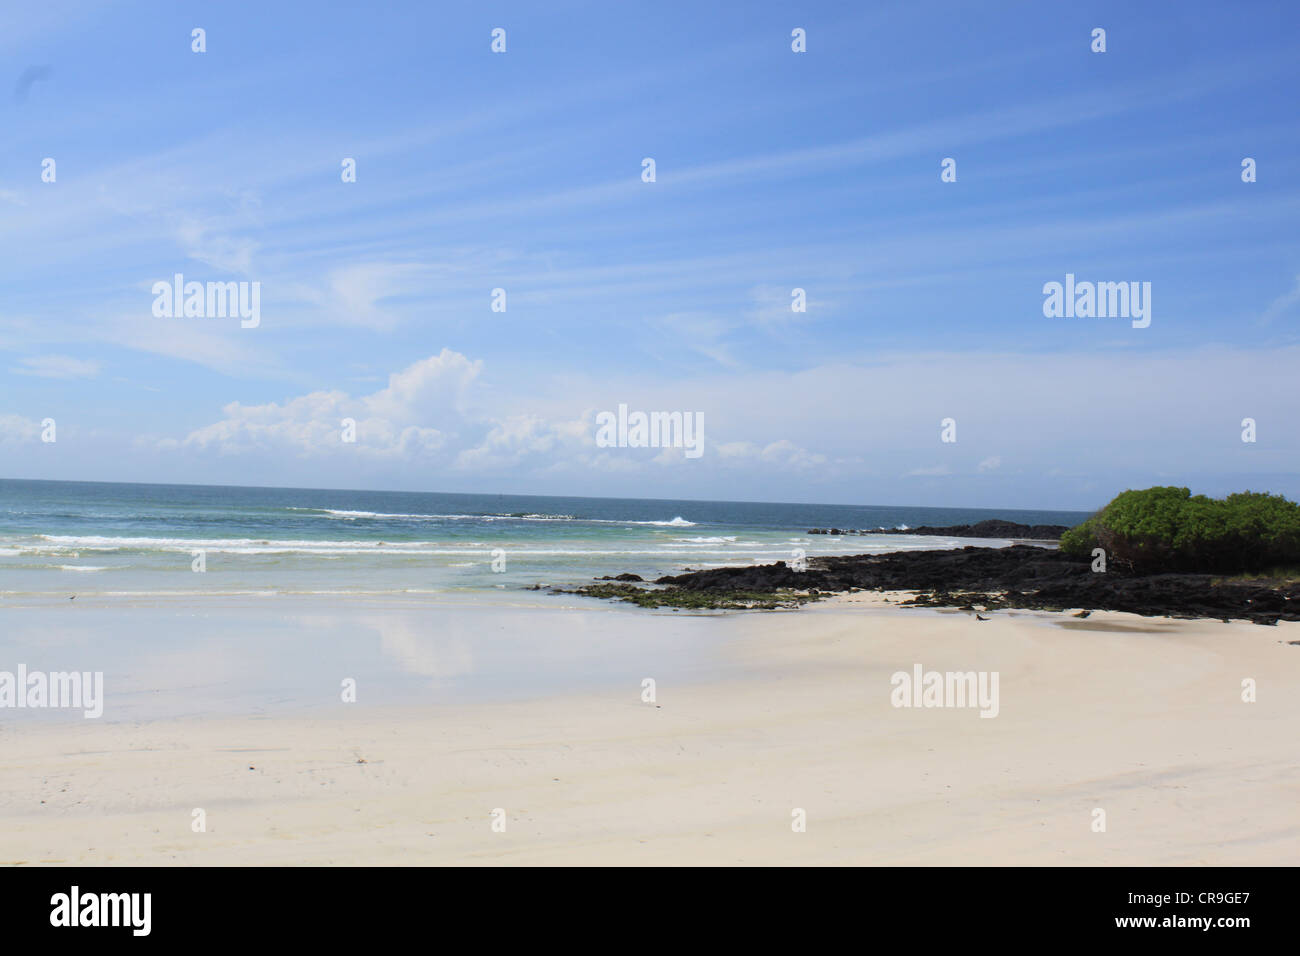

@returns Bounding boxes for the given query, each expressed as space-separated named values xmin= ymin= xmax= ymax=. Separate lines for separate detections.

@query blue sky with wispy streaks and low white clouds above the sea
xmin=0 ymin=0 xmax=1300 ymax=509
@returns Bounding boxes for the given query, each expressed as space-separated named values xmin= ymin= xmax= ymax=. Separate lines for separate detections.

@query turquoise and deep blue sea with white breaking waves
xmin=0 ymin=480 xmax=1087 ymax=596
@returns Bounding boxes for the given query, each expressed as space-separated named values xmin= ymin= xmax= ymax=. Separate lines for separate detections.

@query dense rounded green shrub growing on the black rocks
xmin=1061 ymin=488 xmax=1300 ymax=574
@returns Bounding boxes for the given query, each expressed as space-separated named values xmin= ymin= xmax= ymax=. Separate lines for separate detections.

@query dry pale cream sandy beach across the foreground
xmin=0 ymin=594 xmax=1300 ymax=865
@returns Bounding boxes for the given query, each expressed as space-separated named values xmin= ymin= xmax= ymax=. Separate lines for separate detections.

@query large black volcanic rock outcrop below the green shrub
xmin=655 ymin=545 xmax=1300 ymax=624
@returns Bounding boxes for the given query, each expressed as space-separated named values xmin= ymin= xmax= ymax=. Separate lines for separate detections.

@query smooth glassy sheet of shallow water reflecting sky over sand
xmin=0 ymin=592 xmax=772 ymax=726
